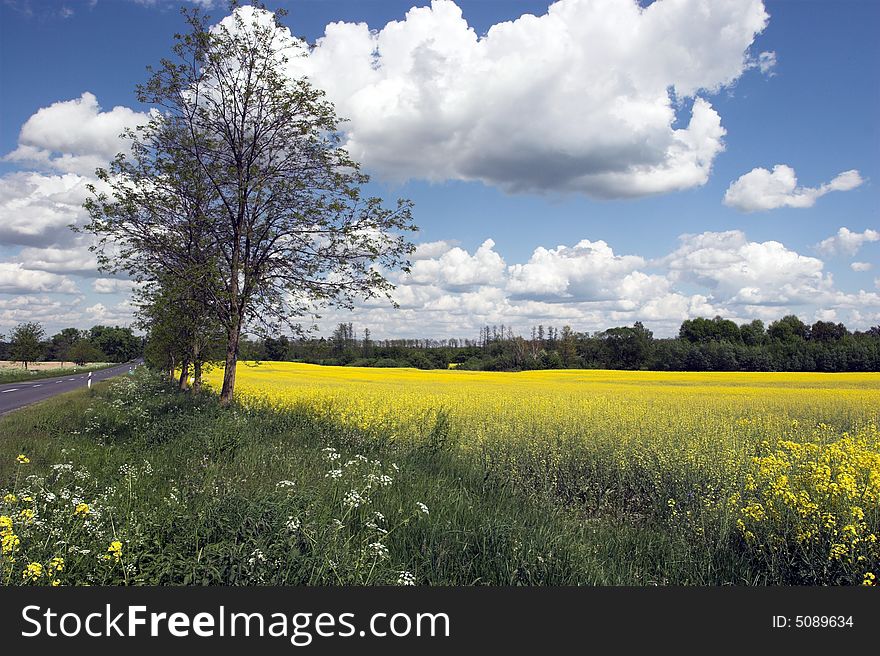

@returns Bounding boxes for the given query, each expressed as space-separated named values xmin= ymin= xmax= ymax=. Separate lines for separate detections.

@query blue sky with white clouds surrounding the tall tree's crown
xmin=0 ymin=0 xmax=880 ymax=337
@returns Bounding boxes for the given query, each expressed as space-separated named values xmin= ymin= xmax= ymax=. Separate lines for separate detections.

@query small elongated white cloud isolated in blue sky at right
xmin=724 ymin=164 xmax=864 ymax=212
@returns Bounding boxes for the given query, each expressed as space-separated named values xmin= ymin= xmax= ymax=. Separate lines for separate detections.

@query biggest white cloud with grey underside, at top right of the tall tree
xmin=256 ymin=0 xmax=769 ymax=197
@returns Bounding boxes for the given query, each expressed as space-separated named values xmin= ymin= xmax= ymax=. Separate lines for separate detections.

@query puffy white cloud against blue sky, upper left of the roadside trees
xmin=5 ymin=92 xmax=149 ymax=175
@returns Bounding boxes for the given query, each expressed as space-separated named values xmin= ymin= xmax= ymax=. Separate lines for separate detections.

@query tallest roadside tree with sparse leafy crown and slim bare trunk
xmin=82 ymin=7 xmax=414 ymax=403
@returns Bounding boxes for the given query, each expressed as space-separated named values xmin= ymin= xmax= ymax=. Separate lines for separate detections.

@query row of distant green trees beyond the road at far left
xmin=0 ymin=322 xmax=143 ymax=369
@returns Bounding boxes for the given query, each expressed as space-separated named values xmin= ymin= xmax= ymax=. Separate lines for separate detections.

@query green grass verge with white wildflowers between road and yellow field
xmin=0 ymin=366 xmax=754 ymax=585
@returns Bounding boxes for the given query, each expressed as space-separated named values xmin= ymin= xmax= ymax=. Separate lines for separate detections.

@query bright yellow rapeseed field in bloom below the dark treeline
xmin=208 ymin=362 xmax=880 ymax=583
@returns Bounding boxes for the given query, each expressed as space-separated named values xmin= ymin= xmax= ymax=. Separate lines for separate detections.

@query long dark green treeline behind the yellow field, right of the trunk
xmin=242 ymin=315 xmax=880 ymax=372
